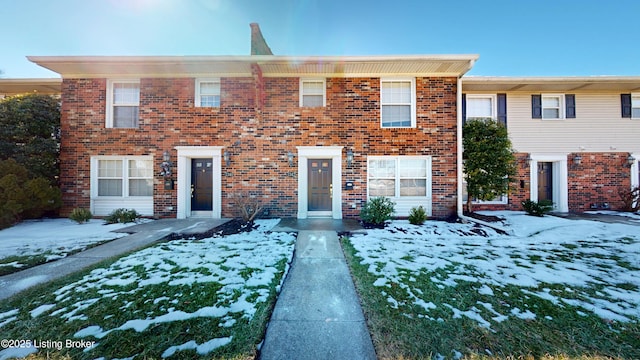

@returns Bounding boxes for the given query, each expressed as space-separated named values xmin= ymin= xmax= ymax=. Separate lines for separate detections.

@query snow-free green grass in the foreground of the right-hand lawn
xmin=342 ymin=238 xmax=640 ymax=360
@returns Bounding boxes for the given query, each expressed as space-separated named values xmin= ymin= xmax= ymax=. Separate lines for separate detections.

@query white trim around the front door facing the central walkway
xmin=297 ymin=146 xmax=343 ymax=219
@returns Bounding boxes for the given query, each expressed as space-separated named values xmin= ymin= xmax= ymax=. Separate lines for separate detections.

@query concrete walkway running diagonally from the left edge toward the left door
xmin=0 ymin=219 xmax=229 ymax=300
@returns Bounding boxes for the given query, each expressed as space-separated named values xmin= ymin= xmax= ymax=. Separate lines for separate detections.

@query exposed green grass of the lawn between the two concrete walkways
xmin=0 ymin=240 xmax=286 ymax=360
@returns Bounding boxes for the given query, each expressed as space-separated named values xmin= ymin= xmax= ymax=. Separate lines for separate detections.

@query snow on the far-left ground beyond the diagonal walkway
xmin=0 ymin=219 xmax=132 ymax=267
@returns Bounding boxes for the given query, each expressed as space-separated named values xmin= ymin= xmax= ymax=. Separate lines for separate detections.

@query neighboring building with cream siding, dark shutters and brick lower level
xmin=462 ymin=76 xmax=640 ymax=212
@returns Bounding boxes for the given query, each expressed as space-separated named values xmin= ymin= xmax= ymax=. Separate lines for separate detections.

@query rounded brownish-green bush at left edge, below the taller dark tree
xmin=0 ymin=159 xmax=61 ymax=228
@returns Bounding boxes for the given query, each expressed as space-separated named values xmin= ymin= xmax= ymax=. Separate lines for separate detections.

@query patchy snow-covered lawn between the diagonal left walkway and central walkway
xmin=0 ymin=220 xmax=295 ymax=359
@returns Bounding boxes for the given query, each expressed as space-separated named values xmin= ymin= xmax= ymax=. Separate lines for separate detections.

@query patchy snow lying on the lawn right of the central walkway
xmin=350 ymin=211 xmax=640 ymax=329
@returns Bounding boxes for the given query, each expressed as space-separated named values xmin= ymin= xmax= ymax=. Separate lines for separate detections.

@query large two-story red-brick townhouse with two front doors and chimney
xmin=29 ymin=28 xmax=477 ymax=219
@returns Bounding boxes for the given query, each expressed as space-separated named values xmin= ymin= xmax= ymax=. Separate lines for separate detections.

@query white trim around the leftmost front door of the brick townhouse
xmin=175 ymin=146 xmax=224 ymax=219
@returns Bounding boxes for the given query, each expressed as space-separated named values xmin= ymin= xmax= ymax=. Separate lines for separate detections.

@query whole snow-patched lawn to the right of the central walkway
xmin=343 ymin=212 xmax=640 ymax=359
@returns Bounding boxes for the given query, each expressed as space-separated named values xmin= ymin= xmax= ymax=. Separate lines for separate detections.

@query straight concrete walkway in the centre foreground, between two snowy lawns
xmin=260 ymin=230 xmax=376 ymax=360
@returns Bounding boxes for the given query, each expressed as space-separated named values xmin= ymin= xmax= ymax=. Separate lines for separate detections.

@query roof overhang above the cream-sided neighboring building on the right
xmin=462 ymin=76 xmax=640 ymax=93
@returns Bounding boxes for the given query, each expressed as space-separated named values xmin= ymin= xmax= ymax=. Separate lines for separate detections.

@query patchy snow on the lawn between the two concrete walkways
xmin=0 ymin=219 xmax=295 ymax=358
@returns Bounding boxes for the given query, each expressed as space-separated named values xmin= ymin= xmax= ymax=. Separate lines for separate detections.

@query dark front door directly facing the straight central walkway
xmin=308 ymin=159 xmax=333 ymax=211
